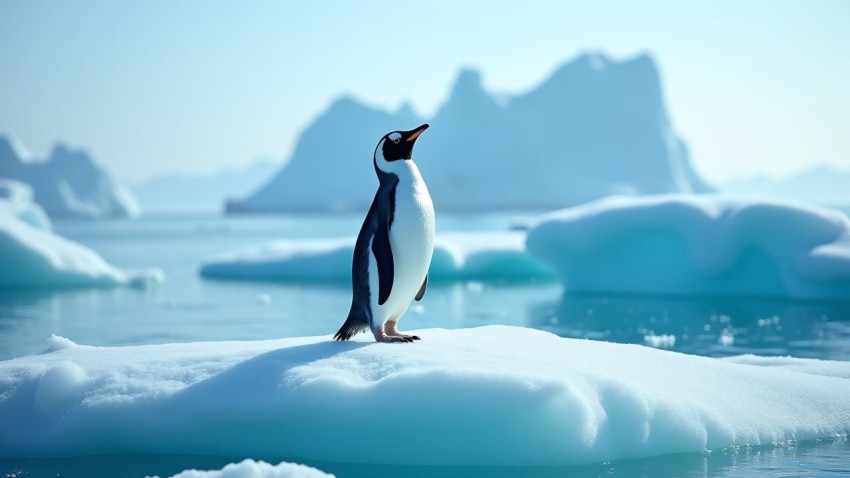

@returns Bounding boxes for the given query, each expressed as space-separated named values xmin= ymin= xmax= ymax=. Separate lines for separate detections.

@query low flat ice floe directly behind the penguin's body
xmin=201 ymin=231 xmax=553 ymax=281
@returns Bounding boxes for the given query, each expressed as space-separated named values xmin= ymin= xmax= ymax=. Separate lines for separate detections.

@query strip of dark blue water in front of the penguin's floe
xmin=0 ymin=437 xmax=850 ymax=478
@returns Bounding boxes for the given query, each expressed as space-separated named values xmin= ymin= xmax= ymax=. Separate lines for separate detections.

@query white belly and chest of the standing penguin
xmin=369 ymin=161 xmax=435 ymax=326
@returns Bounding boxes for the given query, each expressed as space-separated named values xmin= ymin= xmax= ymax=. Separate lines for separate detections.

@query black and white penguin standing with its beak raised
xmin=334 ymin=123 xmax=435 ymax=343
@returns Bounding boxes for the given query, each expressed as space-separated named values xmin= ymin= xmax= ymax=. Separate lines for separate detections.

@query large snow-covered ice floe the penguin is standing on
xmin=0 ymin=326 xmax=850 ymax=465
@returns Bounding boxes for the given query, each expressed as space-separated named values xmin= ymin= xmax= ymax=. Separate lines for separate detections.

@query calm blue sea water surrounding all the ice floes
xmin=0 ymin=213 xmax=850 ymax=477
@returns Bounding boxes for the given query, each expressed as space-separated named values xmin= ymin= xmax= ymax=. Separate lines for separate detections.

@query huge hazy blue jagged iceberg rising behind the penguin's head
xmin=227 ymin=54 xmax=710 ymax=212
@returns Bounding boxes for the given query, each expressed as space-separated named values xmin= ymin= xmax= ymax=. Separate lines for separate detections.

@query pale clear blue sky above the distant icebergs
xmin=0 ymin=0 xmax=850 ymax=184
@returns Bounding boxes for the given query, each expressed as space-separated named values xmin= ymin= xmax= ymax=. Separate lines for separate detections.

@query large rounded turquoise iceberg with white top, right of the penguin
xmin=526 ymin=195 xmax=850 ymax=300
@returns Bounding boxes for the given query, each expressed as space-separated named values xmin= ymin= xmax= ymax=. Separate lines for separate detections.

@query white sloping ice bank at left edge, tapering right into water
xmin=0 ymin=206 xmax=163 ymax=287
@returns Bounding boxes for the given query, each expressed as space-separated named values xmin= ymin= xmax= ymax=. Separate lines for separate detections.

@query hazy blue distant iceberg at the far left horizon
xmin=0 ymin=135 xmax=138 ymax=219
